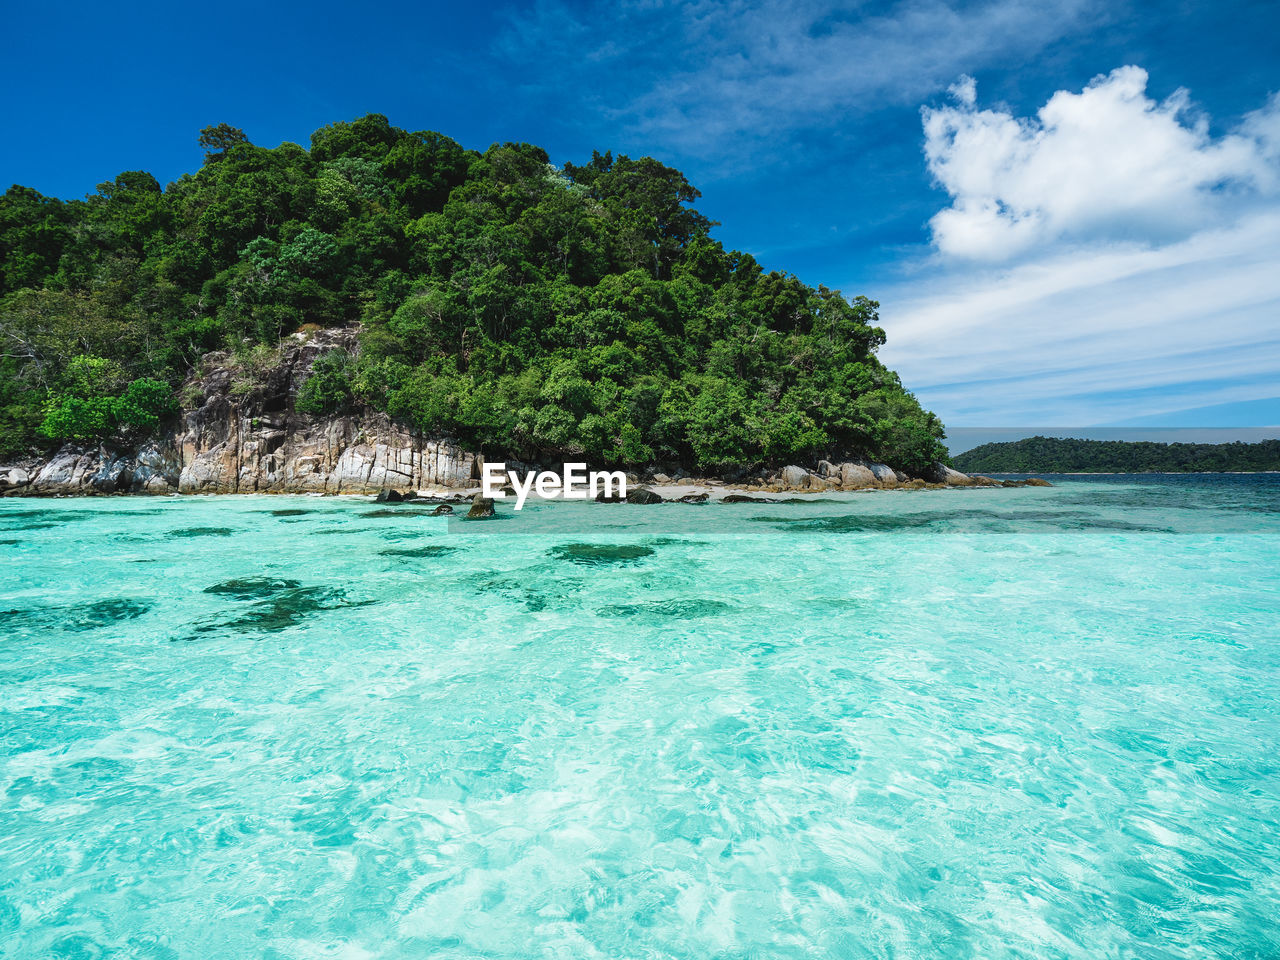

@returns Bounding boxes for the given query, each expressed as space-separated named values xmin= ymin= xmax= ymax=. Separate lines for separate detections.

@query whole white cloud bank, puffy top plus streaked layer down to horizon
xmin=882 ymin=67 xmax=1280 ymax=426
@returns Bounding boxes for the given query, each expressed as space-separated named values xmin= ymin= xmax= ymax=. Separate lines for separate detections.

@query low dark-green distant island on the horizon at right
xmin=952 ymin=436 xmax=1280 ymax=474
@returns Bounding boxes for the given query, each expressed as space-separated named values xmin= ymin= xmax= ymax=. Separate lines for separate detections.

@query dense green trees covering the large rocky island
xmin=0 ymin=115 xmax=945 ymax=470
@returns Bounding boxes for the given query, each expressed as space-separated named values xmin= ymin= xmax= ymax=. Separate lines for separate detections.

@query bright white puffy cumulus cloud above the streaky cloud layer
xmin=924 ymin=67 xmax=1280 ymax=260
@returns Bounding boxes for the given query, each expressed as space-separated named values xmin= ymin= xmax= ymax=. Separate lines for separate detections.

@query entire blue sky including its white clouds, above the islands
xmin=0 ymin=0 xmax=1280 ymax=426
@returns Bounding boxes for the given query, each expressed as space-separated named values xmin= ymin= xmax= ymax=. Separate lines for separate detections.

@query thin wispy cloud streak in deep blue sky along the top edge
xmin=498 ymin=0 xmax=1103 ymax=161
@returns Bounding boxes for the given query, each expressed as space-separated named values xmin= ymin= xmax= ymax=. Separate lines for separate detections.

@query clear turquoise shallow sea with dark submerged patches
xmin=0 ymin=477 xmax=1280 ymax=959
